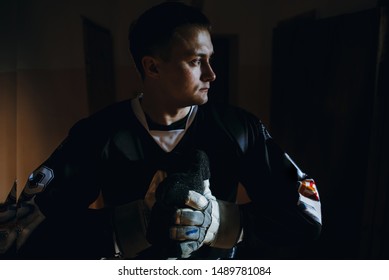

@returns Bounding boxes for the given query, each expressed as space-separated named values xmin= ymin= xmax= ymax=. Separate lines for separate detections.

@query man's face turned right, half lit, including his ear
xmin=154 ymin=27 xmax=216 ymax=108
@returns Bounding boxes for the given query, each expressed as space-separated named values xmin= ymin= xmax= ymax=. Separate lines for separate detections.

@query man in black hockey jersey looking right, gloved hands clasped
xmin=12 ymin=2 xmax=321 ymax=259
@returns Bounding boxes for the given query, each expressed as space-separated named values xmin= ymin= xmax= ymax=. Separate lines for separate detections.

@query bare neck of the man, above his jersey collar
xmin=141 ymin=96 xmax=191 ymax=125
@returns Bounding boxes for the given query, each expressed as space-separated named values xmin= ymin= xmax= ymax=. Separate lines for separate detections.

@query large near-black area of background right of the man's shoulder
xmin=271 ymin=5 xmax=389 ymax=259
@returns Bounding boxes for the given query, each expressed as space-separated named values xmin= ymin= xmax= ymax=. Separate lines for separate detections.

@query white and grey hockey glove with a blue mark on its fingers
xmin=169 ymin=180 xmax=241 ymax=258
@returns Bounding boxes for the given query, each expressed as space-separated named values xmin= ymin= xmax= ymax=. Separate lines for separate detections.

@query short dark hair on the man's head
xmin=128 ymin=2 xmax=211 ymax=79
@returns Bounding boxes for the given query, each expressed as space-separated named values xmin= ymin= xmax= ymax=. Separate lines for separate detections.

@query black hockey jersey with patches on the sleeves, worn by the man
xmin=13 ymin=101 xmax=321 ymax=259
